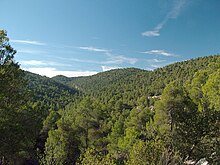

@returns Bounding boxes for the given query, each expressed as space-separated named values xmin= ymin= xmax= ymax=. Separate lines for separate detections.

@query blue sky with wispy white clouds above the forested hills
xmin=0 ymin=0 xmax=220 ymax=77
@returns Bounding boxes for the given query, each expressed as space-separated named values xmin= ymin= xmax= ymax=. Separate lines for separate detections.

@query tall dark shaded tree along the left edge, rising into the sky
xmin=0 ymin=30 xmax=41 ymax=164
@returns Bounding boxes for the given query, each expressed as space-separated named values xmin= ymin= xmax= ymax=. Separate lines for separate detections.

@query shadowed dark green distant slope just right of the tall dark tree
xmin=25 ymin=72 xmax=79 ymax=109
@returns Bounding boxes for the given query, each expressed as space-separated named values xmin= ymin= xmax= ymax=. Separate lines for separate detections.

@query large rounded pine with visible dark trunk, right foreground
xmin=155 ymin=82 xmax=199 ymax=162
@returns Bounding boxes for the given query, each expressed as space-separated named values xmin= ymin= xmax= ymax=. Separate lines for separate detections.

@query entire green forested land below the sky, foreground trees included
xmin=0 ymin=31 xmax=220 ymax=165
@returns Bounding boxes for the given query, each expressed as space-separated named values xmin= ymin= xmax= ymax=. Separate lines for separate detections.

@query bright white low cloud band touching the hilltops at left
xmin=24 ymin=67 xmax=98 ymax=77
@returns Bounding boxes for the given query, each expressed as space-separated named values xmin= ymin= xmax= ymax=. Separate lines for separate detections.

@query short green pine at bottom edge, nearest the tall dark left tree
xmin=41 ymin=110 xmax=80 ymax=165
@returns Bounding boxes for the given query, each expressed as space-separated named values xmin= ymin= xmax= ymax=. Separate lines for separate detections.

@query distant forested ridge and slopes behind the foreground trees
xmin=25 ymin=55 xmax=220 ymax=108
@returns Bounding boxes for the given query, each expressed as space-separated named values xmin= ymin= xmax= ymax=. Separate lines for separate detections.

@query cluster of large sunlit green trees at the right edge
xmin=154 ymin=63 xmax=220 ymax=164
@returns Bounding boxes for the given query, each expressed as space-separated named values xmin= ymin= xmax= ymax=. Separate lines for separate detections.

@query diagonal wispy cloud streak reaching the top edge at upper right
xmin=142 ymin=0 xmax=188 ymax=37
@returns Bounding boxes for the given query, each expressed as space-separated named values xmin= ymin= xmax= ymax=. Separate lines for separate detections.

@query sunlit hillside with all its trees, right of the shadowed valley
xmin=45 ymin=55 xmax=220 ymax=165
